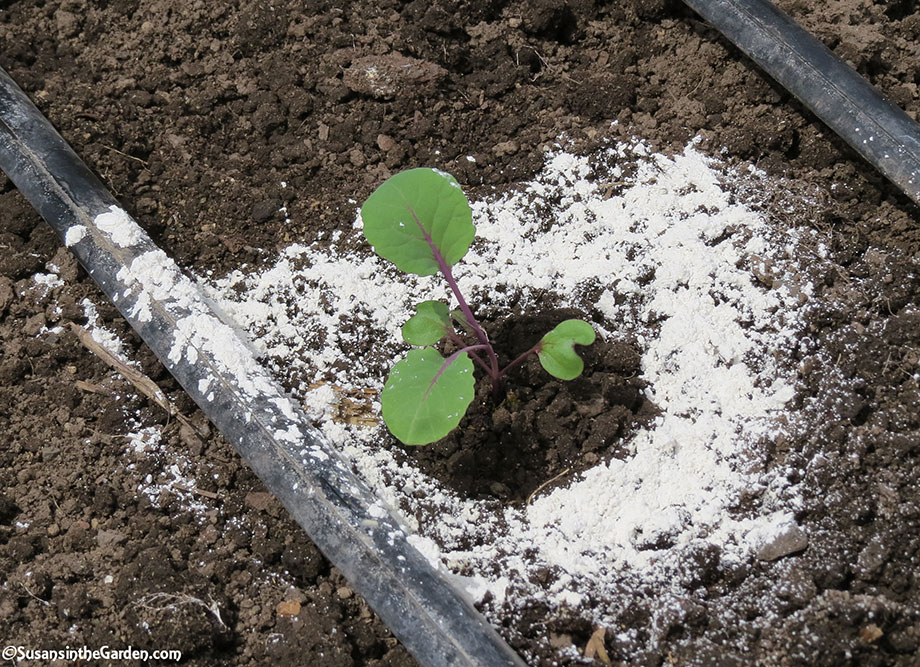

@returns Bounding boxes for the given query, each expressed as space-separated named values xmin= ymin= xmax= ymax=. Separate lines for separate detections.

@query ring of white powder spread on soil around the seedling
xmin=206 ymin=143 xmax=809 ymax=640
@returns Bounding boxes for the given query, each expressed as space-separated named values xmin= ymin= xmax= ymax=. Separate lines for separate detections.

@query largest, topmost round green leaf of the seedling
xmin=361 ymin=168 xmax=476 ymax=276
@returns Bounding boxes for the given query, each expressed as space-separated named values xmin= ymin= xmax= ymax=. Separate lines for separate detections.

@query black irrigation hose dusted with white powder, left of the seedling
xmin=0 ymin=69 xmax=524 ymax=667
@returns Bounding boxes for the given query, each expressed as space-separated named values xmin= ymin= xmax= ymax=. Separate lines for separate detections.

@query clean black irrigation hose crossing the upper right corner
xmin=684 ymin=0 xmax=920 ymax=204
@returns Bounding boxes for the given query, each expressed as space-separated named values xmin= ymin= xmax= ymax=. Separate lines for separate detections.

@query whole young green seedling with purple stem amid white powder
xmin=361 ymin=168 xmax=594 ymax=445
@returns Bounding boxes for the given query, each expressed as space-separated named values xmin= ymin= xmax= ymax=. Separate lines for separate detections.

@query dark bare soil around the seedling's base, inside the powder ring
xmin=394 ymin=309 xmax=655 ymax=503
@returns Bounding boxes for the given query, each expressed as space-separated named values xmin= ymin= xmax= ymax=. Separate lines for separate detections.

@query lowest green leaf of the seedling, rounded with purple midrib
xmin=380 ymin=347 xmax=475 ymax=445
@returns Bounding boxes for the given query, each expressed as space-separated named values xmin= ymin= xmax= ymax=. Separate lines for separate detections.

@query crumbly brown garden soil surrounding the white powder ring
xmin=0 ymin=0 xmax=920 ymax=665
